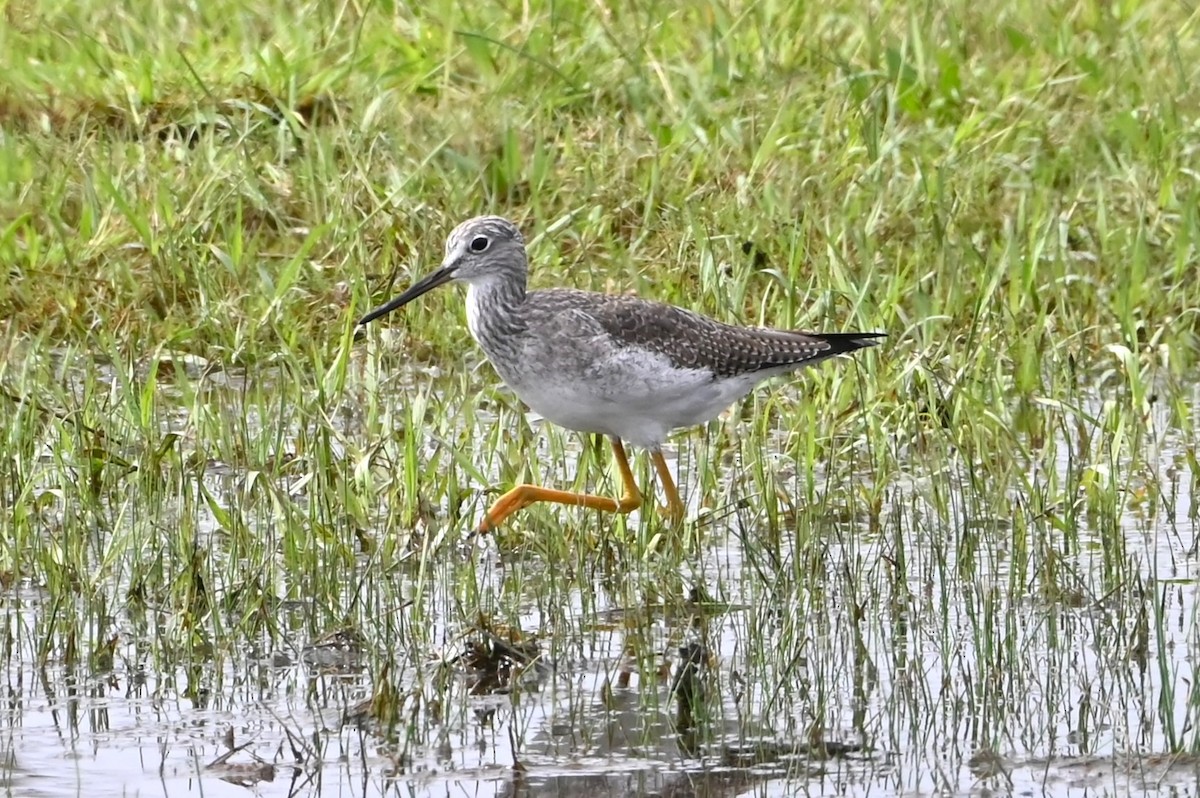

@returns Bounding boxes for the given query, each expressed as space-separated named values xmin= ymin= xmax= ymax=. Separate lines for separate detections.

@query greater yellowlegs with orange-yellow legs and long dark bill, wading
xmin=359 ymin=216 xmax=883 ymax=532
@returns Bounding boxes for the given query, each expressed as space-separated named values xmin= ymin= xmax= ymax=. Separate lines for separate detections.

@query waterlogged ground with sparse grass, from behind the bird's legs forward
xmin=0 ymin=350 xmax=1200 ymax=796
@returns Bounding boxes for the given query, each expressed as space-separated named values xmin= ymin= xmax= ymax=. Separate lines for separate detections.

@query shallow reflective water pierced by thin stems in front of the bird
xmin=0 ymin=357 xmax=1200 ymax=796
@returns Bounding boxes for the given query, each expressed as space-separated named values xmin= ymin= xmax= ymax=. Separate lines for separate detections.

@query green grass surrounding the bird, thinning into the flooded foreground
xmin=0 ymin=0 xmax=1200 ymax=788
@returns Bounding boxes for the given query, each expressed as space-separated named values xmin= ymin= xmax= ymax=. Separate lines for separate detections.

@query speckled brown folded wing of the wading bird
xmin=539 ymin=289 xmax=883 ymax=378
